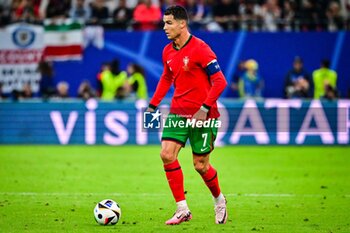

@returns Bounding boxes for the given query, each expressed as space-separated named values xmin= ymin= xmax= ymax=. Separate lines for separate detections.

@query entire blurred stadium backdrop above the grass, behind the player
xmin=0 ymin=0 xmax=350 ymax=145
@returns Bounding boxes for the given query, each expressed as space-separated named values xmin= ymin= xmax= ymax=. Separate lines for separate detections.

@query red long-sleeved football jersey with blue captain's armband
xmin=150 ymin=35 xmax=227 ymax=118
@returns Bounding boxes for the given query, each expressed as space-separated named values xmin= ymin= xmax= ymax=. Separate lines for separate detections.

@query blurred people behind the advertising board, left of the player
xmin=17 ymin=59 xmax=148 ymax=101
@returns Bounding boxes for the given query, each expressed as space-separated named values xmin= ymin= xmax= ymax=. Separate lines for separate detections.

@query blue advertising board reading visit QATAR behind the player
xmin=0 ymin=99 xmax=350 ymax=146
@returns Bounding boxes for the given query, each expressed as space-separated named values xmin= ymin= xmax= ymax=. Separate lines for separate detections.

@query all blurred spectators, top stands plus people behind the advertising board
xmin=0 ymin=0 xmax=350 ymax=101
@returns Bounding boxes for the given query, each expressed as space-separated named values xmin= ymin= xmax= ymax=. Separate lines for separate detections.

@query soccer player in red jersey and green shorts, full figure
xmin=147 ymin=6 xmax=227 ymax=225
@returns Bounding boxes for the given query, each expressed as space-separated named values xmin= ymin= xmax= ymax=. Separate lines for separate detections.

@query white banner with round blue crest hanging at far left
xmin=0 ymin=23 xmax=44 ymax=94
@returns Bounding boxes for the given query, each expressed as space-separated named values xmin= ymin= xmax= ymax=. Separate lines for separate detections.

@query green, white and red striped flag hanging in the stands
xmin=43 ymin=20 xmax=83 ymax=61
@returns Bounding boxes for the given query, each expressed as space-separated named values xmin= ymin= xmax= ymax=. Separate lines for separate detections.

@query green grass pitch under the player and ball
xmin=0 ymin=146 xmax=350 ymax=233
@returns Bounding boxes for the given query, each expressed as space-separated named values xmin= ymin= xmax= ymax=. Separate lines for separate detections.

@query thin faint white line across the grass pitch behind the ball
xmin=0 ymin=192 xmax=350 ymax=198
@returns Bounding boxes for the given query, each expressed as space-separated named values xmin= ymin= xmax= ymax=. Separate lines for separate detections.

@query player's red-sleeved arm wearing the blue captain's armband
xmin=193 ymin=45 xmax=227 ymax=120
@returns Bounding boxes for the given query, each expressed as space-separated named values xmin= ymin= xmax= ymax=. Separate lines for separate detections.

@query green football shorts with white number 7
xmin=162 ymin=113 xmax=218 ymax=155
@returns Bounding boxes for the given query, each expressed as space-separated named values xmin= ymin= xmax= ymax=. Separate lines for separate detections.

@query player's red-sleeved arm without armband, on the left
xmin=147 ymin=53 xmax=173 ymax=111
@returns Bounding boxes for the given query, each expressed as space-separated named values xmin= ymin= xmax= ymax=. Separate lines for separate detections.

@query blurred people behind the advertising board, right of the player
xmin=230 ymin=56 xmax=340 ymax=100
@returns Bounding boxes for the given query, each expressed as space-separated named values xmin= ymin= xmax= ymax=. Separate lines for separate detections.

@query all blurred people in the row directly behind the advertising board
xmin=0 ymin=56 xmax=344 ymax=101
